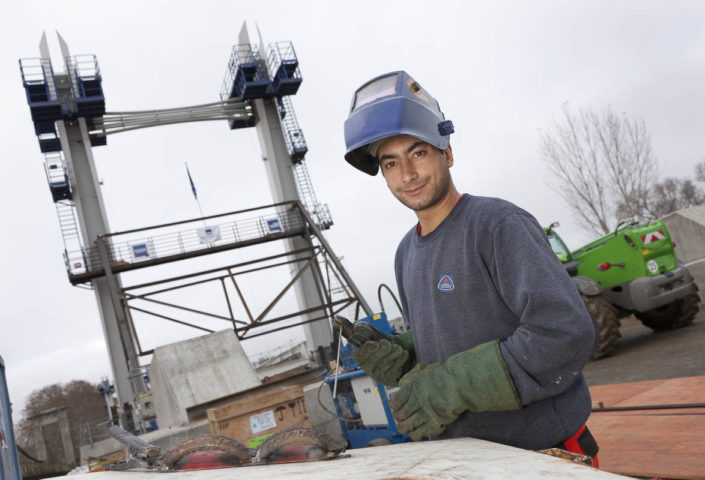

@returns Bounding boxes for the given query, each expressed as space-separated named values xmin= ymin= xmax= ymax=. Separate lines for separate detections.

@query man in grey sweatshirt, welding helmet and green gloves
xmin=345 ymin=72 xmax=597 ymax=462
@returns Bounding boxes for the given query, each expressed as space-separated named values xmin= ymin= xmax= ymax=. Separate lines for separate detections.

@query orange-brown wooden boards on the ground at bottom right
xmin=588 ymin=376 xmax=705 ymax=479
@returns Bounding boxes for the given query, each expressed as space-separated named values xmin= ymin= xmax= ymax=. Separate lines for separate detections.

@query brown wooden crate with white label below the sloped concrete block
xmin=206 ymin=385 xmax=311 ymax=448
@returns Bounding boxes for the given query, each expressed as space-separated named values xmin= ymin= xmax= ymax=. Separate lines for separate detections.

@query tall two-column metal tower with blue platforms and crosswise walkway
xmin=20 ymin=24 xmax=372 ymax=404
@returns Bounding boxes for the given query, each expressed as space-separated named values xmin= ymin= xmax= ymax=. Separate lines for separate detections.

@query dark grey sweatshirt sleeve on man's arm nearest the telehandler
xmin=490 ymin=213 xmax=594 ymax=405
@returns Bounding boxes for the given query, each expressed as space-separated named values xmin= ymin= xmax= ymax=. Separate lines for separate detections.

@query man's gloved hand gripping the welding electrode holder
xmin=353 ymin=339 xmax=409 ymax=387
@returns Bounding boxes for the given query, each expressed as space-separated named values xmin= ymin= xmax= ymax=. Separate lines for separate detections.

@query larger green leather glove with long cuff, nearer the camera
xmin=389 ymin=340 xmax=521 ymax=440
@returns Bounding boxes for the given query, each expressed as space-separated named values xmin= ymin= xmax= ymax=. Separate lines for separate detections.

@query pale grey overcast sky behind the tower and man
xmin=0 ymin=0 xmax=705 ymax=421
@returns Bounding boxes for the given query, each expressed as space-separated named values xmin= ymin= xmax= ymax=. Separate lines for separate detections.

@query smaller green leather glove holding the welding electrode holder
xmin=353 ymin=331 xmax=416 ymax=387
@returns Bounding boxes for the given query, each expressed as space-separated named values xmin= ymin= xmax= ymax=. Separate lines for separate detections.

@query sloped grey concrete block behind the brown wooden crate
xmin=149 ymin=330 xmax=260 ymax=429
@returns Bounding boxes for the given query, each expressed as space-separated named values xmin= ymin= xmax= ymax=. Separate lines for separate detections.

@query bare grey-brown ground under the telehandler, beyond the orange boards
xmin=584 ymin=305 xmax=705 ymax=385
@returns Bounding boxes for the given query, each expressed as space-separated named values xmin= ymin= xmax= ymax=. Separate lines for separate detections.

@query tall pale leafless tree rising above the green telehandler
xmin=541 ymin=106 xmax=658 ymax=233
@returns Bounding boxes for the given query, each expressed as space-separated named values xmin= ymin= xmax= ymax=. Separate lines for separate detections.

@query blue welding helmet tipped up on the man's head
xmin=345 ymin=71 xmax=454 ymax=175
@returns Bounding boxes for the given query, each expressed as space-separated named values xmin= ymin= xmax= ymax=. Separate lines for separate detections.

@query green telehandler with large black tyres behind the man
xmin=544 ymin=221 xmax=700 ymax=359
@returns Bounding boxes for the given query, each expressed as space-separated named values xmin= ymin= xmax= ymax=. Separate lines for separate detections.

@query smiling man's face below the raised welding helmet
xmin=377 ymin=135 xmax=453 ymax=212
